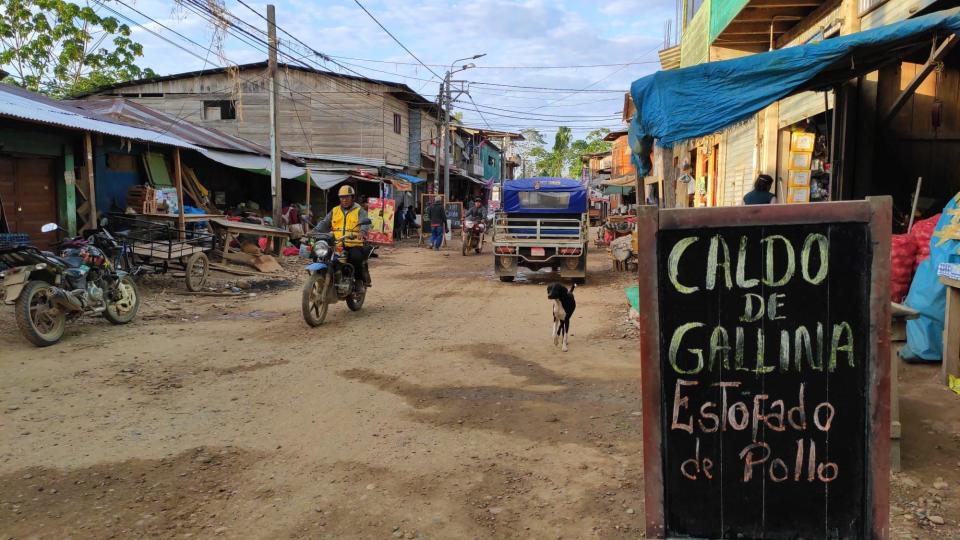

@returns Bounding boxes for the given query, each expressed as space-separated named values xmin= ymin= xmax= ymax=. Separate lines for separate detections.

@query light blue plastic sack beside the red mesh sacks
xmin=900 ymin=200 xmax=960 ymax=362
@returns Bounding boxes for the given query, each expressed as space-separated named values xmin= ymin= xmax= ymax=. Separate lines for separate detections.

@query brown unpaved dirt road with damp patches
xmin=0 ymin=243 xmax=960 ymax=539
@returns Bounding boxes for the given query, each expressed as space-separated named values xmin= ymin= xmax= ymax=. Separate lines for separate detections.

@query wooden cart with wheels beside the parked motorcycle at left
xmin=108 ymin=214 xmax=214 ymax=292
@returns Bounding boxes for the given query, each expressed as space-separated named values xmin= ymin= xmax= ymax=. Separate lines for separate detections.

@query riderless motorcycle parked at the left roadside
xmin=0 ymin=223 xmax=140 ymax=347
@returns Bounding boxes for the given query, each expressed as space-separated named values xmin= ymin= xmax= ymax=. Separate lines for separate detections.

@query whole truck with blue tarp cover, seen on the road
xmin=493 ymin=178 xmax=590 ymax=283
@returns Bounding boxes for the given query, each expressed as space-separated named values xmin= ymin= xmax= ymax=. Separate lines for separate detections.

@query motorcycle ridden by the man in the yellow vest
xmin=300 ymin=219 xmax=374 ymax=326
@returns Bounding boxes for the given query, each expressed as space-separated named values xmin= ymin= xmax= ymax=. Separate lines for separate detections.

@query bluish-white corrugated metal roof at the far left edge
xmin=0 ymin=80 xmax=200 ymax=150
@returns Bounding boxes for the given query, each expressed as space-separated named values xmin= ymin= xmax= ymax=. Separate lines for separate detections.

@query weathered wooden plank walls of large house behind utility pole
xmin=81 ymin=62 xmax=438 ymax=174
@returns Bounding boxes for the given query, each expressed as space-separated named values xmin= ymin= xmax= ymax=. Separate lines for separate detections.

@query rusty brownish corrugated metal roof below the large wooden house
xmin=68 ymin=98 xmax=300 ymax=162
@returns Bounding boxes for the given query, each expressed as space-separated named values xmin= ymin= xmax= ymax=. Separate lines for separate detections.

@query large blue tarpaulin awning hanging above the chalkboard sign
xmin=629 ymin=9 xmax=960 ymax=175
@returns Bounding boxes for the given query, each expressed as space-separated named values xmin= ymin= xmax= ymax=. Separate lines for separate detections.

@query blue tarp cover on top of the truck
xmin=503 ymin=178 xmax=588 ymax=214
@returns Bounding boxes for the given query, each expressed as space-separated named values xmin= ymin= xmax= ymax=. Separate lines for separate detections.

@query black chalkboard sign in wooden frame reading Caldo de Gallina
xmin=637 ymin=197 xmax=891 ymax=539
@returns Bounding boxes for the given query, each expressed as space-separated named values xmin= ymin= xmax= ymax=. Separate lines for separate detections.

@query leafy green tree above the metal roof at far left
xmin=0 ymin=0 xmax=156 ymax=97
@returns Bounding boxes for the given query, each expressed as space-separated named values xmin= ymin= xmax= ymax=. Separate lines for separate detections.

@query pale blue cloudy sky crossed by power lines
xmin=105 ymin=0 xmax=676 ymax=141
